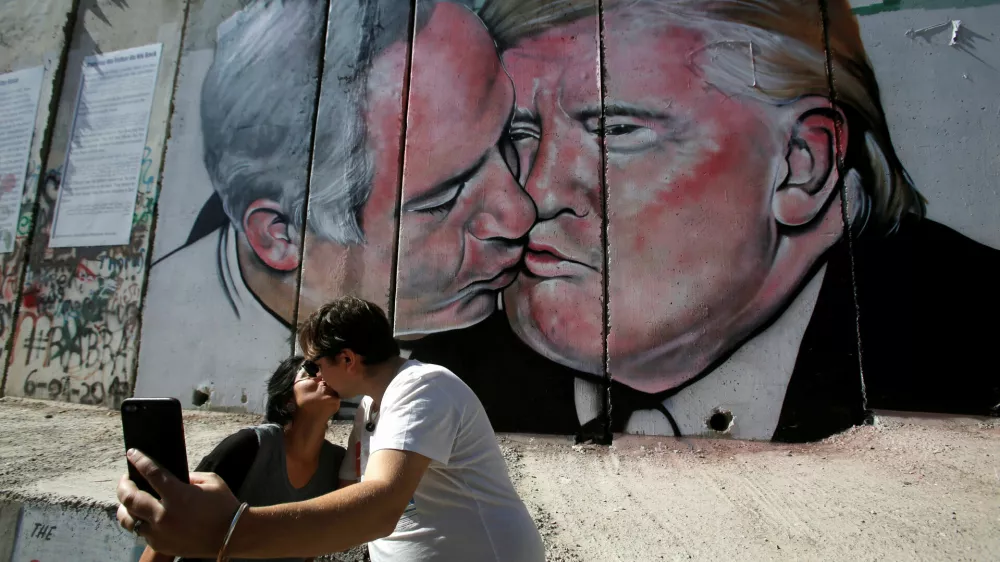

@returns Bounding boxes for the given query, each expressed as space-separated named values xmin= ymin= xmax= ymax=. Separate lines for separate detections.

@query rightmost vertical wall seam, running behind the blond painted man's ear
xmin=818 ymin=0 xmax=868 ymax=417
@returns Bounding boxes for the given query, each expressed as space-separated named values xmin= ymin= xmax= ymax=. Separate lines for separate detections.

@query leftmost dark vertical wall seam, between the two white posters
xmin=0 ymin=0 xmax=83 ymax=397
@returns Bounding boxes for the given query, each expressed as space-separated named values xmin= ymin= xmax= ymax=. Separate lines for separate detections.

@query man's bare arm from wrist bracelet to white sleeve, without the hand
xmin=229 ymin=449 xmax=431 ymax=558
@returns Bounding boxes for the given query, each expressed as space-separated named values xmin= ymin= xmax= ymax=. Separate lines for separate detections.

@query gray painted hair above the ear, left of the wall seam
xmin=201 ymin=0 xmax=326 ymax=234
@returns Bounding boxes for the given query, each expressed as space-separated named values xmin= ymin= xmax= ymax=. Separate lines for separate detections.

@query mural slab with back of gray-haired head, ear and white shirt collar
xmin=136 ymin=0 xmax=326 ymax=411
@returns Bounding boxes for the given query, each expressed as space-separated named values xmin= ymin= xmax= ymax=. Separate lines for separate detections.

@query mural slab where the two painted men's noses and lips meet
xmin=396 ymin=0 xmax=605 ymax=434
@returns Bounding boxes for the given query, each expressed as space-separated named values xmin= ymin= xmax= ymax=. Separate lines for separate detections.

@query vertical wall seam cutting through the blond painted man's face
xmin=597 ymin=0 xmax=613 ymax=444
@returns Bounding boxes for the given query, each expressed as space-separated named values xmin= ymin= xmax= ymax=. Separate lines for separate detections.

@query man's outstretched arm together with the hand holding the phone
xmin=117 ymin=449 xmax=430 ymax=559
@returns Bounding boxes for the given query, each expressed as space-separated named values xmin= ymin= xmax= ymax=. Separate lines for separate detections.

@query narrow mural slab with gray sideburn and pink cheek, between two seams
xmin=298 ymin=0 xmax=412 ymax=336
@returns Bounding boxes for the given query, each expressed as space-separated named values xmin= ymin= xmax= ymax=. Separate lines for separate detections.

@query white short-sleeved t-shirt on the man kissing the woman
xmin=341 ymin=361 xmax=545 ymax=562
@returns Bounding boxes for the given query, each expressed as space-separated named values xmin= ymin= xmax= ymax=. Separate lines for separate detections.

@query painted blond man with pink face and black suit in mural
xmin=410 ymin=0 xmax=1000 ymax=441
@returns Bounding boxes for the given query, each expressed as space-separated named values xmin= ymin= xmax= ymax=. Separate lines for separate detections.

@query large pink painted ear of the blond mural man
xmin=772 ymin=97 xmax=847 ymax=226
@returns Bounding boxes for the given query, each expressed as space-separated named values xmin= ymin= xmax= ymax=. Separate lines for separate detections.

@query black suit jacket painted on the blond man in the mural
xmin=411 ymin=217 xmax=1000 ymax=442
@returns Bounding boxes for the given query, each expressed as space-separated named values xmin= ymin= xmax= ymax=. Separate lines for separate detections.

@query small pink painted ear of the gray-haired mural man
xmin=243 ymin=199 xmax=300 ymax=271
